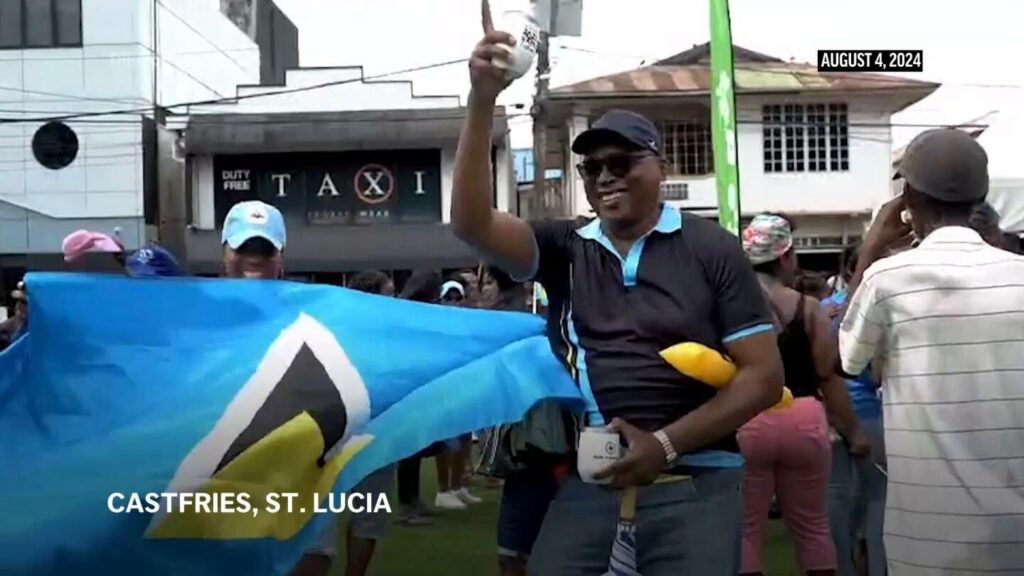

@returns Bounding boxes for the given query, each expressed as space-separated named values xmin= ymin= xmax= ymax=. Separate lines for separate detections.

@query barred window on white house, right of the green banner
xmin=761 ymin=104 xmax=850 ymax=172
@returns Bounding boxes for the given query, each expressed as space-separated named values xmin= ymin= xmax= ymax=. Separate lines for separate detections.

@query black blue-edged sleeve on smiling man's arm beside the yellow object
xmin=700 ymin=222 xmax=774 ymax=344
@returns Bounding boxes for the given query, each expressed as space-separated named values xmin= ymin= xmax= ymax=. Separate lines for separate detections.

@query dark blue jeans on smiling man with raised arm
xmin=527 ymin=468 xmax=743 ymax=576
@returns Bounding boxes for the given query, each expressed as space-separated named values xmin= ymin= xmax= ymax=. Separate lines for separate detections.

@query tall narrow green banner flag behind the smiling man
xmin=711 ymin=0 xmax=740 ymax=236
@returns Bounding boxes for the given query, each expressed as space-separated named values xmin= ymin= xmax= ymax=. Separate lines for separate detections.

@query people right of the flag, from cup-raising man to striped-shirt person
xmin=452 ymin=20 xmax=1024 ymax=576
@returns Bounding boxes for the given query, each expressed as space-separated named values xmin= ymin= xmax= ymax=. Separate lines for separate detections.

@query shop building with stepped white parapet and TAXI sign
xmin=179 ymin=67 xmax=518 ymax=284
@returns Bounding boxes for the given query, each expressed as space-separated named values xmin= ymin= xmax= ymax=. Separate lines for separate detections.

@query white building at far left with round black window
xmin=0 ymin=0 xmax=298 ymax=270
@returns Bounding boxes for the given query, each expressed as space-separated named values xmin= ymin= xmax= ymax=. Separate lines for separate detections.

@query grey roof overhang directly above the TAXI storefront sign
xmin=183 ymin=108 xmax=508 ymax=155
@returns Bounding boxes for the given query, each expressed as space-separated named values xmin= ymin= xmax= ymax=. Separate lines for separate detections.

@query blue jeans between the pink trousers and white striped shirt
xmin=828 ymin=420 xmax=886 ymax=576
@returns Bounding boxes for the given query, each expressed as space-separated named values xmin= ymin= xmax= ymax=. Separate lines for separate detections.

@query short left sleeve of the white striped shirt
xmin=839 ymin=270 xmax=887 ymax=374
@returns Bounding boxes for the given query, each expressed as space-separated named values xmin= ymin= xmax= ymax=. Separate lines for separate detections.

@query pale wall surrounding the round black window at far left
xmin=0 ymin=0 xmax=260 ymax=253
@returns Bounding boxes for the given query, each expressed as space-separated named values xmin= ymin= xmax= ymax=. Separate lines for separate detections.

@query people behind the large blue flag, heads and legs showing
xmin=0 ymin=201 xmax=527 ymax=576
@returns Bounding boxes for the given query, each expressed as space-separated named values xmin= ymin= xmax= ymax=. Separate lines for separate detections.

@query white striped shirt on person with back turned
xmin=840 ymin=227 xmax=1024 ymax=576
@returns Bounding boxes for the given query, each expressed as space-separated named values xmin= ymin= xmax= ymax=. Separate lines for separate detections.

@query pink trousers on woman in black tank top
xmin=738 ymin=398 xmax=836 ymax=574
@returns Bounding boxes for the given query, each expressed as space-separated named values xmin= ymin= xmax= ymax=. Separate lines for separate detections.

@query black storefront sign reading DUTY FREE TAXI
xmin=213 ymin=150 xmax=441 ymax=225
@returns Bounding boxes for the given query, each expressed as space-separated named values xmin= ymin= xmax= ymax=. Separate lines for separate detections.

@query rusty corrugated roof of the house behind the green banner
xmin=551 ymin=61 xmax=939 ymax=98
